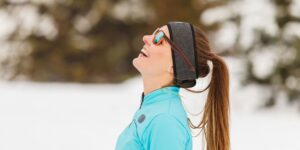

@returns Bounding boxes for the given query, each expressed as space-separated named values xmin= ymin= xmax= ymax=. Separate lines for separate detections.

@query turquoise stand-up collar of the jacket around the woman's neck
xmin=140 ymin=86 xmax=179 ymax=108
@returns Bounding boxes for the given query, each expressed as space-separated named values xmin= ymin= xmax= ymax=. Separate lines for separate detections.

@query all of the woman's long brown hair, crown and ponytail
xmin=186 ymin=26 xmax=230 ymax=150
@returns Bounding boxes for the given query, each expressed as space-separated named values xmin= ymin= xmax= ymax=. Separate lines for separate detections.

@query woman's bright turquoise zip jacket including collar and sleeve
xmin=115 ymin=86 xmax=192 ymax=150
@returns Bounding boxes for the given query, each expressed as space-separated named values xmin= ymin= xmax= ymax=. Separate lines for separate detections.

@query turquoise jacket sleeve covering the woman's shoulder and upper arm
xmin=142 ymin=114 xmax=188 ymax=150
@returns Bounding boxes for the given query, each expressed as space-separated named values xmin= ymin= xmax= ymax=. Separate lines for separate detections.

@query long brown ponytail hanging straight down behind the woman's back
xmin=203 ymin=56 xmax=230 ymax=150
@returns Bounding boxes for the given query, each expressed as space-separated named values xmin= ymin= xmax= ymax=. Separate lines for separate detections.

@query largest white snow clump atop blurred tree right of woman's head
xmin=200 ymin=0 xmax=279 ymax=50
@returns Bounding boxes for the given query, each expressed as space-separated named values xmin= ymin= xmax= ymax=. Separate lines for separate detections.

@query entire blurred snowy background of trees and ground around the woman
xmin=0 ymin=0 xmax=300 ymax=150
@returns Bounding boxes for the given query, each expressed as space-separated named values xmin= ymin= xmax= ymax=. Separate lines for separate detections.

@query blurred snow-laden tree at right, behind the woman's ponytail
xmin=202 ymin=0 xmax=300 ymax=106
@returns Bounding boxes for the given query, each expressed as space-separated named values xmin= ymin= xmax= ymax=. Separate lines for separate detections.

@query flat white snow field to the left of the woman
xmin=0 ymin=83 xmax=139 ymax=150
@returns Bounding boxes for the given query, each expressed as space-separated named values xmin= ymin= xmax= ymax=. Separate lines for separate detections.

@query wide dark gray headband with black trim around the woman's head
xmin=167 ymin=22 xmax=198 ymax=88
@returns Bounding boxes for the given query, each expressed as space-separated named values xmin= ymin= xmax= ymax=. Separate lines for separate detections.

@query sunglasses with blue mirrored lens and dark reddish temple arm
xmin=152 ymin=28 xmax=196 ymax=72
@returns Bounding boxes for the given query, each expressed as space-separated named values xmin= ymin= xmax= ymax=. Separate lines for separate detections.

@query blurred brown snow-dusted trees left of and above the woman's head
xmin=0 ymin=0 xmax=223 ymax=83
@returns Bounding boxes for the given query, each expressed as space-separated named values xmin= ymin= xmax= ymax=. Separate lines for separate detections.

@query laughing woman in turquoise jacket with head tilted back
xmin=116 ymin=22 xmax=230 ymax=150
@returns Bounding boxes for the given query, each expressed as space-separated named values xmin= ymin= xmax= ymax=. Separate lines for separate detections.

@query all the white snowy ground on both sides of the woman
xmin=0 ymin=56 xmax=300 ymax=150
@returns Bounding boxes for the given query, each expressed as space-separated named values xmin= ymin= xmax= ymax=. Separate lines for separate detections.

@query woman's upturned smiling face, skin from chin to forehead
xmin=132 ymin=25 xmax=173 ymax=76
